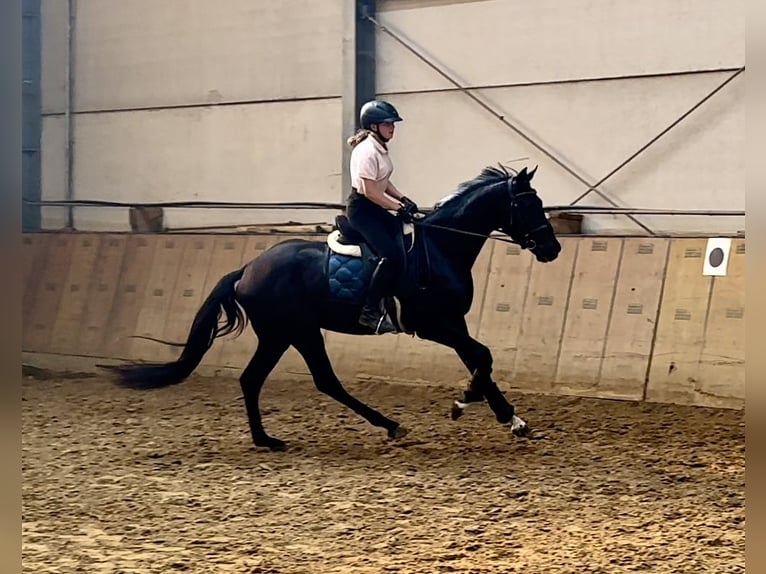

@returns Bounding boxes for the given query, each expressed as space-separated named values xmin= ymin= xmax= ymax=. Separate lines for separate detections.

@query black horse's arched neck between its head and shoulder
xmin=428 ymin=184 xmax=505 ymax=268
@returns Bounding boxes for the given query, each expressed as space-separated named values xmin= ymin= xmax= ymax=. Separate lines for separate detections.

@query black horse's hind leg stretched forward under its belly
xmin=293 ymin=329 xmax=407 ymax=438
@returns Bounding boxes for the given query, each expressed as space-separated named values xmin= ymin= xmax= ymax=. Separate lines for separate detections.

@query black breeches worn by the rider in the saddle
xmin=346 ymin=192 xmax=404 ymax=276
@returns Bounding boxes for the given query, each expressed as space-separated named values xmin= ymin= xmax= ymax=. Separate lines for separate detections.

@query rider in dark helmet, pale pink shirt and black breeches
xmin=346 ymin=100 xmax=418 ymax=334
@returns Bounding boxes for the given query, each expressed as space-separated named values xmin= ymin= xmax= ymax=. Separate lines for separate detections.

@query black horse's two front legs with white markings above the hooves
xmin=418 ymin=317 xmax=529 ymax=436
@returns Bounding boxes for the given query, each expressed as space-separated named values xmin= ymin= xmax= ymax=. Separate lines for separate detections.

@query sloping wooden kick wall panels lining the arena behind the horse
xmin=23 ymin=233 xmax=745 ymax=408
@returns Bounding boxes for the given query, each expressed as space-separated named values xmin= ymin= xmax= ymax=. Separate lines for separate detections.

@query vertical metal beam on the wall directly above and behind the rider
xmin=340 ymin=0 xmax=376 ymax=202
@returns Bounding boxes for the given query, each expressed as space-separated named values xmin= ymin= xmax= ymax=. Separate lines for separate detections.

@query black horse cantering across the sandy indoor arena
xmin=109 ymin=167 xmax=561 ymax=450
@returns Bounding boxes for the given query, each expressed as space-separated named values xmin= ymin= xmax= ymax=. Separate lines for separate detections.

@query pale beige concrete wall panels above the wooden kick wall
xmin=42 ymin=0 xmax=745 ymax=233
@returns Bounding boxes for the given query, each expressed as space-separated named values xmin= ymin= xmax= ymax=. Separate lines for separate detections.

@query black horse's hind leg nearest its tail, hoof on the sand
xmin=240 ymin=337 xmax=290 ymax=451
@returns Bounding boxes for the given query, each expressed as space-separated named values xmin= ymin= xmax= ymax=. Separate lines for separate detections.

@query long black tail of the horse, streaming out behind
xmin=99 ymin=267 xmax=247 ymax=389
